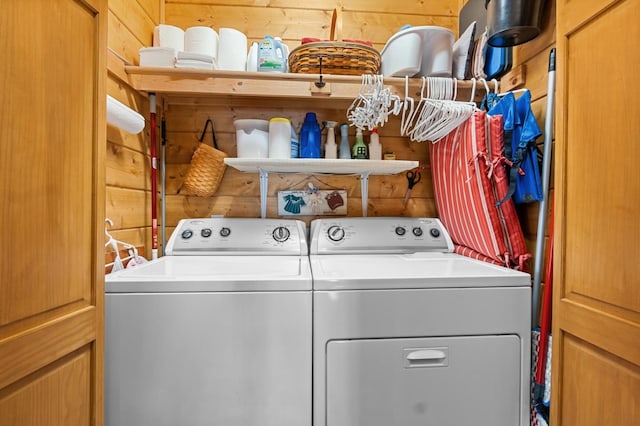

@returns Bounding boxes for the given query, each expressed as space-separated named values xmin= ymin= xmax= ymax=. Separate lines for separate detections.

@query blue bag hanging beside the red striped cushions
xmin=488 ymin=90 xmax=542 ymax=205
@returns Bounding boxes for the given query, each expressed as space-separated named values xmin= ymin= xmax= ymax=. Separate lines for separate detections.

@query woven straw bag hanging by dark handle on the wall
xmin=178 ymin=119 xmax=227 ymax=197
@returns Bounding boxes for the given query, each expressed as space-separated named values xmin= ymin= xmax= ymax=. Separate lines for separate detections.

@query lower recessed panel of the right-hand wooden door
xmin=562 ymin=336 xmax=640 ymax=426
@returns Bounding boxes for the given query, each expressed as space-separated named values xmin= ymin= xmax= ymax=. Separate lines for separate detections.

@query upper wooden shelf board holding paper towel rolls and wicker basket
xmin=125 ymin=66 xmax=484 ymax=101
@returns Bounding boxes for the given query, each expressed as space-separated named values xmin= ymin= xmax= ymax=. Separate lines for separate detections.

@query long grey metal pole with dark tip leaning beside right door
xmin=531 ymin=48 xmax=556 ymax=327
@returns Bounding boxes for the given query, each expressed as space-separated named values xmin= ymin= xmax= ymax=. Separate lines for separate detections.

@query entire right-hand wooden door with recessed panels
xmin=550 ymin=0 xmax=640 ymax=426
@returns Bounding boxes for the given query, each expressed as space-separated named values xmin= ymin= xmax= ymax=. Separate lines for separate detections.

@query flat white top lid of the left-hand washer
xmin=105 ymin=256 xmax=311 ymax=293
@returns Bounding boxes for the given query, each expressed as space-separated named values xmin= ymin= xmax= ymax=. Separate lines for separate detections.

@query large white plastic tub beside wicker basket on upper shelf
xmin=381 ymin=26 xmax=455 ymax=77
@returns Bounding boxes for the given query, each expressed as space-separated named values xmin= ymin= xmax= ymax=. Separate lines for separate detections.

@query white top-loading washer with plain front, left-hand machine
xmin=105 ymin=218 xmax=312 ymax=426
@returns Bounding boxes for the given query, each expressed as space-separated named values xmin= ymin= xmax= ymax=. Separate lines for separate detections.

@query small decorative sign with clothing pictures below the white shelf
xmin=278 ymin=188 xmax=347 ymax=216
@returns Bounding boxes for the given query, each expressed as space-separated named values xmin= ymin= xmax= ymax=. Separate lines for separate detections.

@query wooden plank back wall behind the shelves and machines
xmin=159 ymin=0 xmax=459 ymax=240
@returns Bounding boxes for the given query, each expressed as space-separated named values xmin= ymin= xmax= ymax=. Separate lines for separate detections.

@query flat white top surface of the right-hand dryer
xmin=311 ymin=253 xmax=531 ymax=290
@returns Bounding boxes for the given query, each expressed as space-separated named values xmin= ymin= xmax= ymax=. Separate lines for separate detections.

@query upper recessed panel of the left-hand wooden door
xmin=0 ymin=0 xmax=98 ymax=326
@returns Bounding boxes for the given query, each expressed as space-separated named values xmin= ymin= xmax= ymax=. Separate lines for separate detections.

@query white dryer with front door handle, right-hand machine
xmin=310 ymin=218 xmax=531 ymax=426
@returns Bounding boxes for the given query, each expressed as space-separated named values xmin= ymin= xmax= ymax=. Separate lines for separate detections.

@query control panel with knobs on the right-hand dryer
xmin=310 ymin=217 xmax=453 ymax=254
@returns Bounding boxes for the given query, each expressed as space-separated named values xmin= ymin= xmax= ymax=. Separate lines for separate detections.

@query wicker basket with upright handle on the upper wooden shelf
xmin=289 ymin=8 xmax=382 ymax=75
